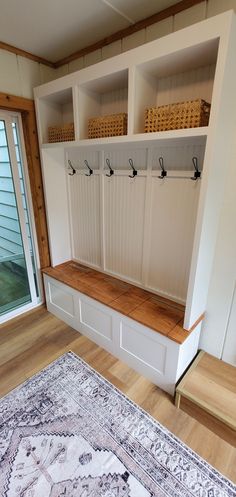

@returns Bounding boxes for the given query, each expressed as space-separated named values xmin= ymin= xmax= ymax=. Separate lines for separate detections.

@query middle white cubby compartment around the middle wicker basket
xmin=78 ymin=69 xmax=128 ymax=140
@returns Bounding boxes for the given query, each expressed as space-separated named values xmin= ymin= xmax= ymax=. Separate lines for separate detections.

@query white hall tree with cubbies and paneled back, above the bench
xmin=35 ymin=11 xmax=236 ymax=376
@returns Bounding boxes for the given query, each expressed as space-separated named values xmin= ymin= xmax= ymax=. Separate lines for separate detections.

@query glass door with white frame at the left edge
xmin=0 ymin=111 xmax=38 ymax=321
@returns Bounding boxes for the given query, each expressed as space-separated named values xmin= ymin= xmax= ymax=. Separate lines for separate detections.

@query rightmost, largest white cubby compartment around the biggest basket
xmin=134 ymin=39 xmax=218 ymax=133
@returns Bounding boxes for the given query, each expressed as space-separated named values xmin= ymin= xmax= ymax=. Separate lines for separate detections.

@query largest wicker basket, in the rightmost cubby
xmin=145 ymin=99 xmax=211 ymax=133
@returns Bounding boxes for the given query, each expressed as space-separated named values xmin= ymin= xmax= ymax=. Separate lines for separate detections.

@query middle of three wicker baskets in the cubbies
xmin=88 ymin=113 xmax=127 ymax=138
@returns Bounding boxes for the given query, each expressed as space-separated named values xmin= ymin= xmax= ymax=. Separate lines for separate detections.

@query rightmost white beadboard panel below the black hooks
xmin=146 ymin=178 xmax=200 ymax=302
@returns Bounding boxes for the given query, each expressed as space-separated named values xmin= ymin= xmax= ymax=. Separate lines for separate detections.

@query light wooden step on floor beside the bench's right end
xmin=175 ymin=351 xmax=236 ymax=447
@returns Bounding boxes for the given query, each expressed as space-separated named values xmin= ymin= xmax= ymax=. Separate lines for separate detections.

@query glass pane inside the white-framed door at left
xmin=0 ymin=120 xmax=31 ymax=315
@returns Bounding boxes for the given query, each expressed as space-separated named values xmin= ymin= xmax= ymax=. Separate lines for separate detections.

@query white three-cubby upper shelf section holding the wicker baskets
xmin=35 ymin=10 xmax=229 ymax=146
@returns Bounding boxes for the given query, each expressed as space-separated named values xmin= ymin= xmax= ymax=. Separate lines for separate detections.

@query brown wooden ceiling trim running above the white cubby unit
xmin=54 ymin=0 xmax=203 ymax=68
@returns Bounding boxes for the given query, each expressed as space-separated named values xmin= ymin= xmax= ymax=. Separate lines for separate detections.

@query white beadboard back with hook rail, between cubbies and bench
xmin=67 ymin=141 xmax=205 ymax=302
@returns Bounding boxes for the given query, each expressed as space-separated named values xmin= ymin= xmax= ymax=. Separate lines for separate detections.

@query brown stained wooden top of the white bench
xmin=43 ymin=261 xmax=193 ymax=344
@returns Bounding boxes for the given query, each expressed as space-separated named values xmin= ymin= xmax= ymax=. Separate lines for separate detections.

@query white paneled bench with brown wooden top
xmin=43 ymin=261 xmax=201 ymax=395
